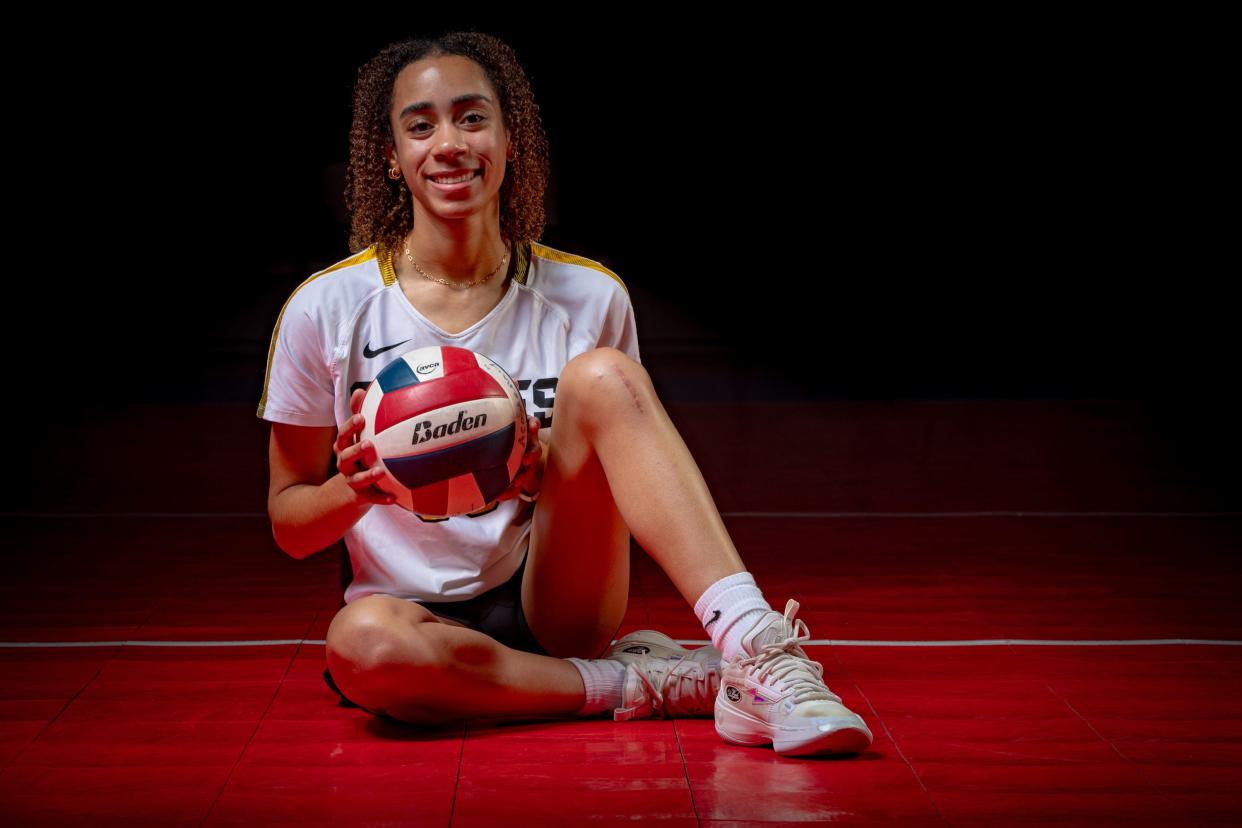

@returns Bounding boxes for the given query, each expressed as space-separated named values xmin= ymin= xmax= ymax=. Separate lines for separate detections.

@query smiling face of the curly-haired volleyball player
xmin=388 ymin=55 xmax=509 ymax=226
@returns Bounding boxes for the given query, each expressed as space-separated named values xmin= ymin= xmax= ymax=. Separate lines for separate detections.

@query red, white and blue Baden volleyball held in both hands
xmin=361 ymin=345 xmax=528 ymax=518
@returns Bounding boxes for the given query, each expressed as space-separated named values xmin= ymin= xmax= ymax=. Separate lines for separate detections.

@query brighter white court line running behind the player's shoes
xmin=0 ymin=638 xmax=1242 ymax=649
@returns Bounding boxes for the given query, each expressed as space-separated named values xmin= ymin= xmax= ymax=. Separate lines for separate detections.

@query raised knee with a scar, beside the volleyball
xmin=556 ymin=348 xmax=657 ymax=422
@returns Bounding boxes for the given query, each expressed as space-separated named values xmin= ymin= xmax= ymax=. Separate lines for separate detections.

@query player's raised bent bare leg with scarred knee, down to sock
xmin=522 ymin=348 xmax=745 ymax=657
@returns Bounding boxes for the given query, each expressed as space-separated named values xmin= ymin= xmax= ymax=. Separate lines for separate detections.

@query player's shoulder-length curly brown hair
xmin=345 ymin=31 xmax=549 ymax=253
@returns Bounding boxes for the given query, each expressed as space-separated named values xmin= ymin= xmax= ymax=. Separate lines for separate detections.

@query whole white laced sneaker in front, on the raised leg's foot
xmin=715 ymin=600 xmax=872 ymax=756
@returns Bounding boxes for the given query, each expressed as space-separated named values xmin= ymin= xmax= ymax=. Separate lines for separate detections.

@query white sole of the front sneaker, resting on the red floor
xmin=715 ymin=698 xmax=872 ymax=756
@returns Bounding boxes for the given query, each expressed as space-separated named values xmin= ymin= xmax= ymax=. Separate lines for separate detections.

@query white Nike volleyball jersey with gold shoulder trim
xmin=258 ymin=243 xmax=638 ymax=603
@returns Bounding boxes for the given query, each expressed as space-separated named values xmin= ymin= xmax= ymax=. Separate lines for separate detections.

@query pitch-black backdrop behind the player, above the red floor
xmin=10 ymin=15 xmax=1237 ymax=410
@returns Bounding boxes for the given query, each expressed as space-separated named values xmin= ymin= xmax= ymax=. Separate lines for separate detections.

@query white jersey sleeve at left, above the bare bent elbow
xmin=258 ymin=292 xmax=337 ymax=426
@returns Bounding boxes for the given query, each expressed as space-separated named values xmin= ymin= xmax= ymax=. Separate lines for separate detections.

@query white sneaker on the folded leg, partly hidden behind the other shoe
xmin=605 ymin=629 xmax=720 ymax=721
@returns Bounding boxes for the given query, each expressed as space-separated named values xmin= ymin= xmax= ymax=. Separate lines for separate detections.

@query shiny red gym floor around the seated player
xmin=0 ymin=401 xmax=1242 ymax=828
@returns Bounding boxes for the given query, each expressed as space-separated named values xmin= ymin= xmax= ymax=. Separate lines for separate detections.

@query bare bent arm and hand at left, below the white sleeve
xmin=267 ymin=390 xmax=394 ymax=559
